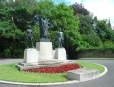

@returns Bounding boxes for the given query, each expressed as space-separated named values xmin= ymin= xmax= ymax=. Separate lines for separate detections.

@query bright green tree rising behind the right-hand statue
xmin=52 ymin=3 xmax=81 ymax=58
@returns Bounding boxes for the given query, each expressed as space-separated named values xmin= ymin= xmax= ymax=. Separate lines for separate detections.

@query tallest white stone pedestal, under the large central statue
xmin=36 ymin=42 xmax=53 ymax=60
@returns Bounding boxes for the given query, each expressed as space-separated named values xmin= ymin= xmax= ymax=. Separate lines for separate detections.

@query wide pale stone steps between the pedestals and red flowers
xmin=16 ymin=59 xmax=76 ymax=71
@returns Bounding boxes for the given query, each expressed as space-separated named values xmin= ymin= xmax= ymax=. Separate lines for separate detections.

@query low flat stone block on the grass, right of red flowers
xmin=67 ymin=68 xmax=100 ymax=81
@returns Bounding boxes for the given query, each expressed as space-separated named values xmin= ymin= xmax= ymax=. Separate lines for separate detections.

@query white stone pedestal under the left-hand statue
xmin=24 ymin=48 xmax=39 ymax=63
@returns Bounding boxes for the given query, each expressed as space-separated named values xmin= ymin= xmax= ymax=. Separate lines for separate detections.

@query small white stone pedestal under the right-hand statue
xmin=54 ymin=48 xmax=67 ymax=60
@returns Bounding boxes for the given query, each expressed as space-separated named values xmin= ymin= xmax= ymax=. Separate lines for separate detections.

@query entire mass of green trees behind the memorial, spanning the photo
xmin=0 ymin=0 xmax=114 ymax=59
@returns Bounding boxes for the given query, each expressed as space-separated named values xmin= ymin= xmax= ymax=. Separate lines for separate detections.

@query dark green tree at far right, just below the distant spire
xmin=93 ymin=17 xmax=114 ymax=46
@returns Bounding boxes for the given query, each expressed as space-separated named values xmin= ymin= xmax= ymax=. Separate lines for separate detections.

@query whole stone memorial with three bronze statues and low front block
xmin=16 ymin=16 xmax=100 ymax=81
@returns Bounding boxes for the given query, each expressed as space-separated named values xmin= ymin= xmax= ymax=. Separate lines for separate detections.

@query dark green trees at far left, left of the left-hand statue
xmin=0 ymin=0 xmax=36 ymax=58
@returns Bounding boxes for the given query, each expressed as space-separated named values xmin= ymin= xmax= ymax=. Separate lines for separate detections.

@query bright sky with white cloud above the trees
xmin=53 ymin=0 xmax=114 ymax=26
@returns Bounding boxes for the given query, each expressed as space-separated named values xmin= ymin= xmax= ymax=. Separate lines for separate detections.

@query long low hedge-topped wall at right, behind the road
xmin=77 ymin=47 xmax=114 ymax=58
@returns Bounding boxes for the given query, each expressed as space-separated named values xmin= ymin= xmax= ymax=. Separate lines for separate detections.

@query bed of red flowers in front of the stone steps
xmin=24 ymin=64 xmax=80 ymax=73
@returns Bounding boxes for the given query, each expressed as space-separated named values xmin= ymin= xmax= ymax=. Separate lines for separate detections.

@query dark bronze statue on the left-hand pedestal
xmin=26 ymin=25 xmax=34 ymax=48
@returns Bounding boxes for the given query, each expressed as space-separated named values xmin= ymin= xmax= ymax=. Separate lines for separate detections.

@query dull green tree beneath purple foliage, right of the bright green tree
xmin=77 ymin=14 xmax=102 ymax=48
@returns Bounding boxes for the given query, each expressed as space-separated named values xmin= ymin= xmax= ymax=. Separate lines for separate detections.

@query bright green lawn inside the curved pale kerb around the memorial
xmin=0 ymin=62 xmax=104 ymax=83
